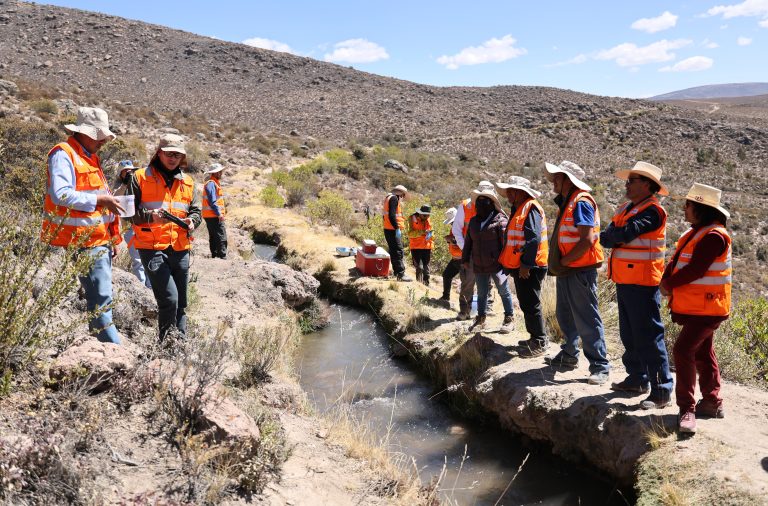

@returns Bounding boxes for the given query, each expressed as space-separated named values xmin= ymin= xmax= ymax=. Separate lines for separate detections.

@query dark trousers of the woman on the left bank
xmin=139 ymin=247 xmax=189 ymax=341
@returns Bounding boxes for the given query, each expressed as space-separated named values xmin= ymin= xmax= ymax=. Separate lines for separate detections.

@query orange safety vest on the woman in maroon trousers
xmin=670 ymin=224 xmax=732 ymax=316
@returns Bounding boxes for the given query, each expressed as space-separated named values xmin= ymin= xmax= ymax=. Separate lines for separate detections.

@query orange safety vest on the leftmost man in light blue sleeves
xmin=40 ymin=137 xmax=122 ymax=248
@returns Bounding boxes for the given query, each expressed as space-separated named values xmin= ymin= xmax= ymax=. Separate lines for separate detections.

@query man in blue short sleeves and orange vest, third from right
xmin=544 ymin=160 xmax=611 ymax=385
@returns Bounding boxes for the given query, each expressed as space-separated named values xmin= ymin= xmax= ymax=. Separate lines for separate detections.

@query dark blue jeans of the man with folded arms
xmin=616 ymin=284 xmax=674 ymax=398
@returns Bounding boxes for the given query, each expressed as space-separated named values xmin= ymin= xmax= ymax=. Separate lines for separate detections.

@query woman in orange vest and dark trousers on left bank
xmin=128 ymin=134 xmax=202 ymax=342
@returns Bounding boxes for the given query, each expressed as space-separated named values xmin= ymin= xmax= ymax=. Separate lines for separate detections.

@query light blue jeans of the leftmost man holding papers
xmin=79 ymin=246 xmax=120 ymax=344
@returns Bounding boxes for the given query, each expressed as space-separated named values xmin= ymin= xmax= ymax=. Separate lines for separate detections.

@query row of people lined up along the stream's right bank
xmin=384 ymin=161 xmax=732 ymax=433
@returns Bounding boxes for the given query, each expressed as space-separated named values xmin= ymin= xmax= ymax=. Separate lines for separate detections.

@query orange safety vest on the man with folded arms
xmin=608 ymin=197 xmax=667 ymax=286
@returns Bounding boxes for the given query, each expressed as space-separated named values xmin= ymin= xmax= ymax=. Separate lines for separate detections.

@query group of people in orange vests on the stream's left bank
xmin=41 ymin=107 xmax=227 ymax=344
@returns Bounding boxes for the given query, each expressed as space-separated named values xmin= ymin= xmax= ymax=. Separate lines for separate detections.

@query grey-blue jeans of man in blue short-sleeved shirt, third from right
xmin=555 ymin=269 xmax=611 ymax=374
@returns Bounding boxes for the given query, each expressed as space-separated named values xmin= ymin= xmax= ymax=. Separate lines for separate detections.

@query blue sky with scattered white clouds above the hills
xmin=43 ymin=0 xmax=768 ymax=97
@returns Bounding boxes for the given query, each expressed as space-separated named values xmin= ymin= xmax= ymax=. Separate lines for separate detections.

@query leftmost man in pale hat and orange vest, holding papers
xmin=41 ymin=107 xmax=123 ymax=344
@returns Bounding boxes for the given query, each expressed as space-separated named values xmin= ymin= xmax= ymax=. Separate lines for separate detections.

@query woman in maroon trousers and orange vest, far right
xmin=660 ymin=183 xmax=732 ymax=434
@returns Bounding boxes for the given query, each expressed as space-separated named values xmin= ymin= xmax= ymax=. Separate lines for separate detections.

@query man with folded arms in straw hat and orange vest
xmin=600 ymin=162 xmax=674 ymax=409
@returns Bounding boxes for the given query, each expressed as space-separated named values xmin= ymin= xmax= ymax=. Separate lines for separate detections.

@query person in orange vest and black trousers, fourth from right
xmin=496 ymin=176 xmax=549 ymax=357
